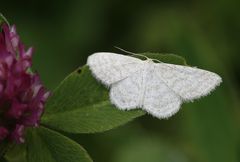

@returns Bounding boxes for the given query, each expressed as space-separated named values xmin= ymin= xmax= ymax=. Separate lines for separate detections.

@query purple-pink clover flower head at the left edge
xmin=0 ymin=24 xmax=49 ymax=143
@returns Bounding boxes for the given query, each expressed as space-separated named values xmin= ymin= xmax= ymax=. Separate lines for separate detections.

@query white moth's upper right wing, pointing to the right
xmin=155 ymin=63 xmax=222 ymax=101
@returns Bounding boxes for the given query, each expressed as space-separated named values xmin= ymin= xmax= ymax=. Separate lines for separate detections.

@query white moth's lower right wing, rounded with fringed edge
xmin=143 ymin=66 xmax=182 ymax=119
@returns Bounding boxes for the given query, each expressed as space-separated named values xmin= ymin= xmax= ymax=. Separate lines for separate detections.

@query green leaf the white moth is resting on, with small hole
xmin=42 ymin=53 xmax=186 ymax=133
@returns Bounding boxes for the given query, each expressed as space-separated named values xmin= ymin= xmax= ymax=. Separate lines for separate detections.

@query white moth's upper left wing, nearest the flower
xmin=87 ymin=52 xmax=143 ymax=86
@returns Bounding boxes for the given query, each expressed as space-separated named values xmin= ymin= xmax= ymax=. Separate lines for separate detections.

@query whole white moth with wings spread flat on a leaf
xmin=87 ymin=52 xmax=222 ymax=119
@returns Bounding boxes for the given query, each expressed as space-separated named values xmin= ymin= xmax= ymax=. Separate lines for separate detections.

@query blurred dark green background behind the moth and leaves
xmin=0 ymin=0 xmax=240 ymax=162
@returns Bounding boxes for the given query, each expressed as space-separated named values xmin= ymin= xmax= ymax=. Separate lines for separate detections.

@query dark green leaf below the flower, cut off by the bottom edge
xmin=26 ymin=127 xmax=92 ymax=162
